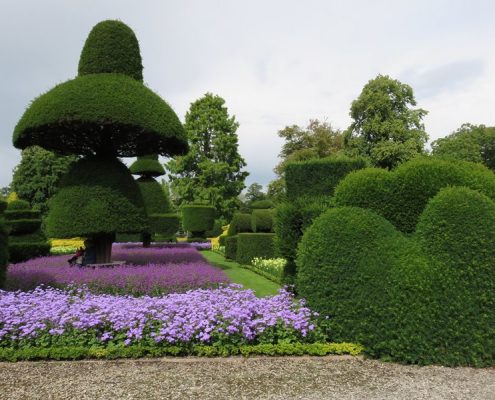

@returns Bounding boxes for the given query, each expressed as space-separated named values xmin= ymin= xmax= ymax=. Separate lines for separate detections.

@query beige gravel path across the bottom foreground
xmin=0 ymin=356 xmax=495 ymax=400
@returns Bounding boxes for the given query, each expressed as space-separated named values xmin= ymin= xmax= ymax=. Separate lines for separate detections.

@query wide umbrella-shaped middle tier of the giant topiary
xmin=13 ymin=74 xmax=188 ymax=157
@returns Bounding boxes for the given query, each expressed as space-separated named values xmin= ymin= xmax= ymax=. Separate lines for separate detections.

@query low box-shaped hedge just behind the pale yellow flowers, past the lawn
xmin=236 ymin=233 xmax=275 ymax=265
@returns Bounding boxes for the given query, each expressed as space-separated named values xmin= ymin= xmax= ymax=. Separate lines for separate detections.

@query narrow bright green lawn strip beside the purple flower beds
xmin=201 ymin=250 xmax=280 ymax=297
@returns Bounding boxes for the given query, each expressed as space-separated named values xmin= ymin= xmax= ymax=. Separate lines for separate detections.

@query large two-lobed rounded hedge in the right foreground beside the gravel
xmin=297 ymin=187 xmax=495 ymax=366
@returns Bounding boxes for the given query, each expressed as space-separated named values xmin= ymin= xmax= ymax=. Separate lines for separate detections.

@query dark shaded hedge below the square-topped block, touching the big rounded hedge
xmin=274 ymin=197 xmax=332 ymax=284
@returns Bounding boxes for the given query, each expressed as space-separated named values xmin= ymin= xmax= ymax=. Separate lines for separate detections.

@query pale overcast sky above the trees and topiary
xmin=0 ymin=0 xmax=495 ymax=186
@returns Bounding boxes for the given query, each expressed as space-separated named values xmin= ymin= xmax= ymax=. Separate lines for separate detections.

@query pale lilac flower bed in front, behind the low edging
xmin=0 ymin=285 xmax=316 ymax=346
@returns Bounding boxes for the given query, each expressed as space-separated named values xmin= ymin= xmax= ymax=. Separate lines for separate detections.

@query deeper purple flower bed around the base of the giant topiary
xmin=6 ymin=245 xmax=230 ymax=295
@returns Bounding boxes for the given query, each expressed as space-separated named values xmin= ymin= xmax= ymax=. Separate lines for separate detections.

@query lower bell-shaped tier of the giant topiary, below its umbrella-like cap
xmin=46 ymin=157 xmax=147 ymax=238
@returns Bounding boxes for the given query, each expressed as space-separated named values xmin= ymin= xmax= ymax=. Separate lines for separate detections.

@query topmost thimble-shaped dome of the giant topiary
xmin=79 ymin=20 xmax=143 ymax=82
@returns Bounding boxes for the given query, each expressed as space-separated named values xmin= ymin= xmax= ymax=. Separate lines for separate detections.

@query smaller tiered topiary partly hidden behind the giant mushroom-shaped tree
xmin=129 ymin=154 xmax=179 ymax=247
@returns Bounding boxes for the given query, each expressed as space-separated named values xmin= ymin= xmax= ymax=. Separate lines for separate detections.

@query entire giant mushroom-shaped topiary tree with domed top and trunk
xmin=13 ymin=20 xmax=188 ymax=263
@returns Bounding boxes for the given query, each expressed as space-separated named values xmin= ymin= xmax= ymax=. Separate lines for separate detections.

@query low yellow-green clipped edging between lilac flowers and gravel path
xmin=0 ymin=343 xmax=363 ymax=362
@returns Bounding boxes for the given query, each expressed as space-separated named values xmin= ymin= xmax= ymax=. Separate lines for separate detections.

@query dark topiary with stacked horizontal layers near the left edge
xmin=5 ymin=200 xmax=50 ymax=263
